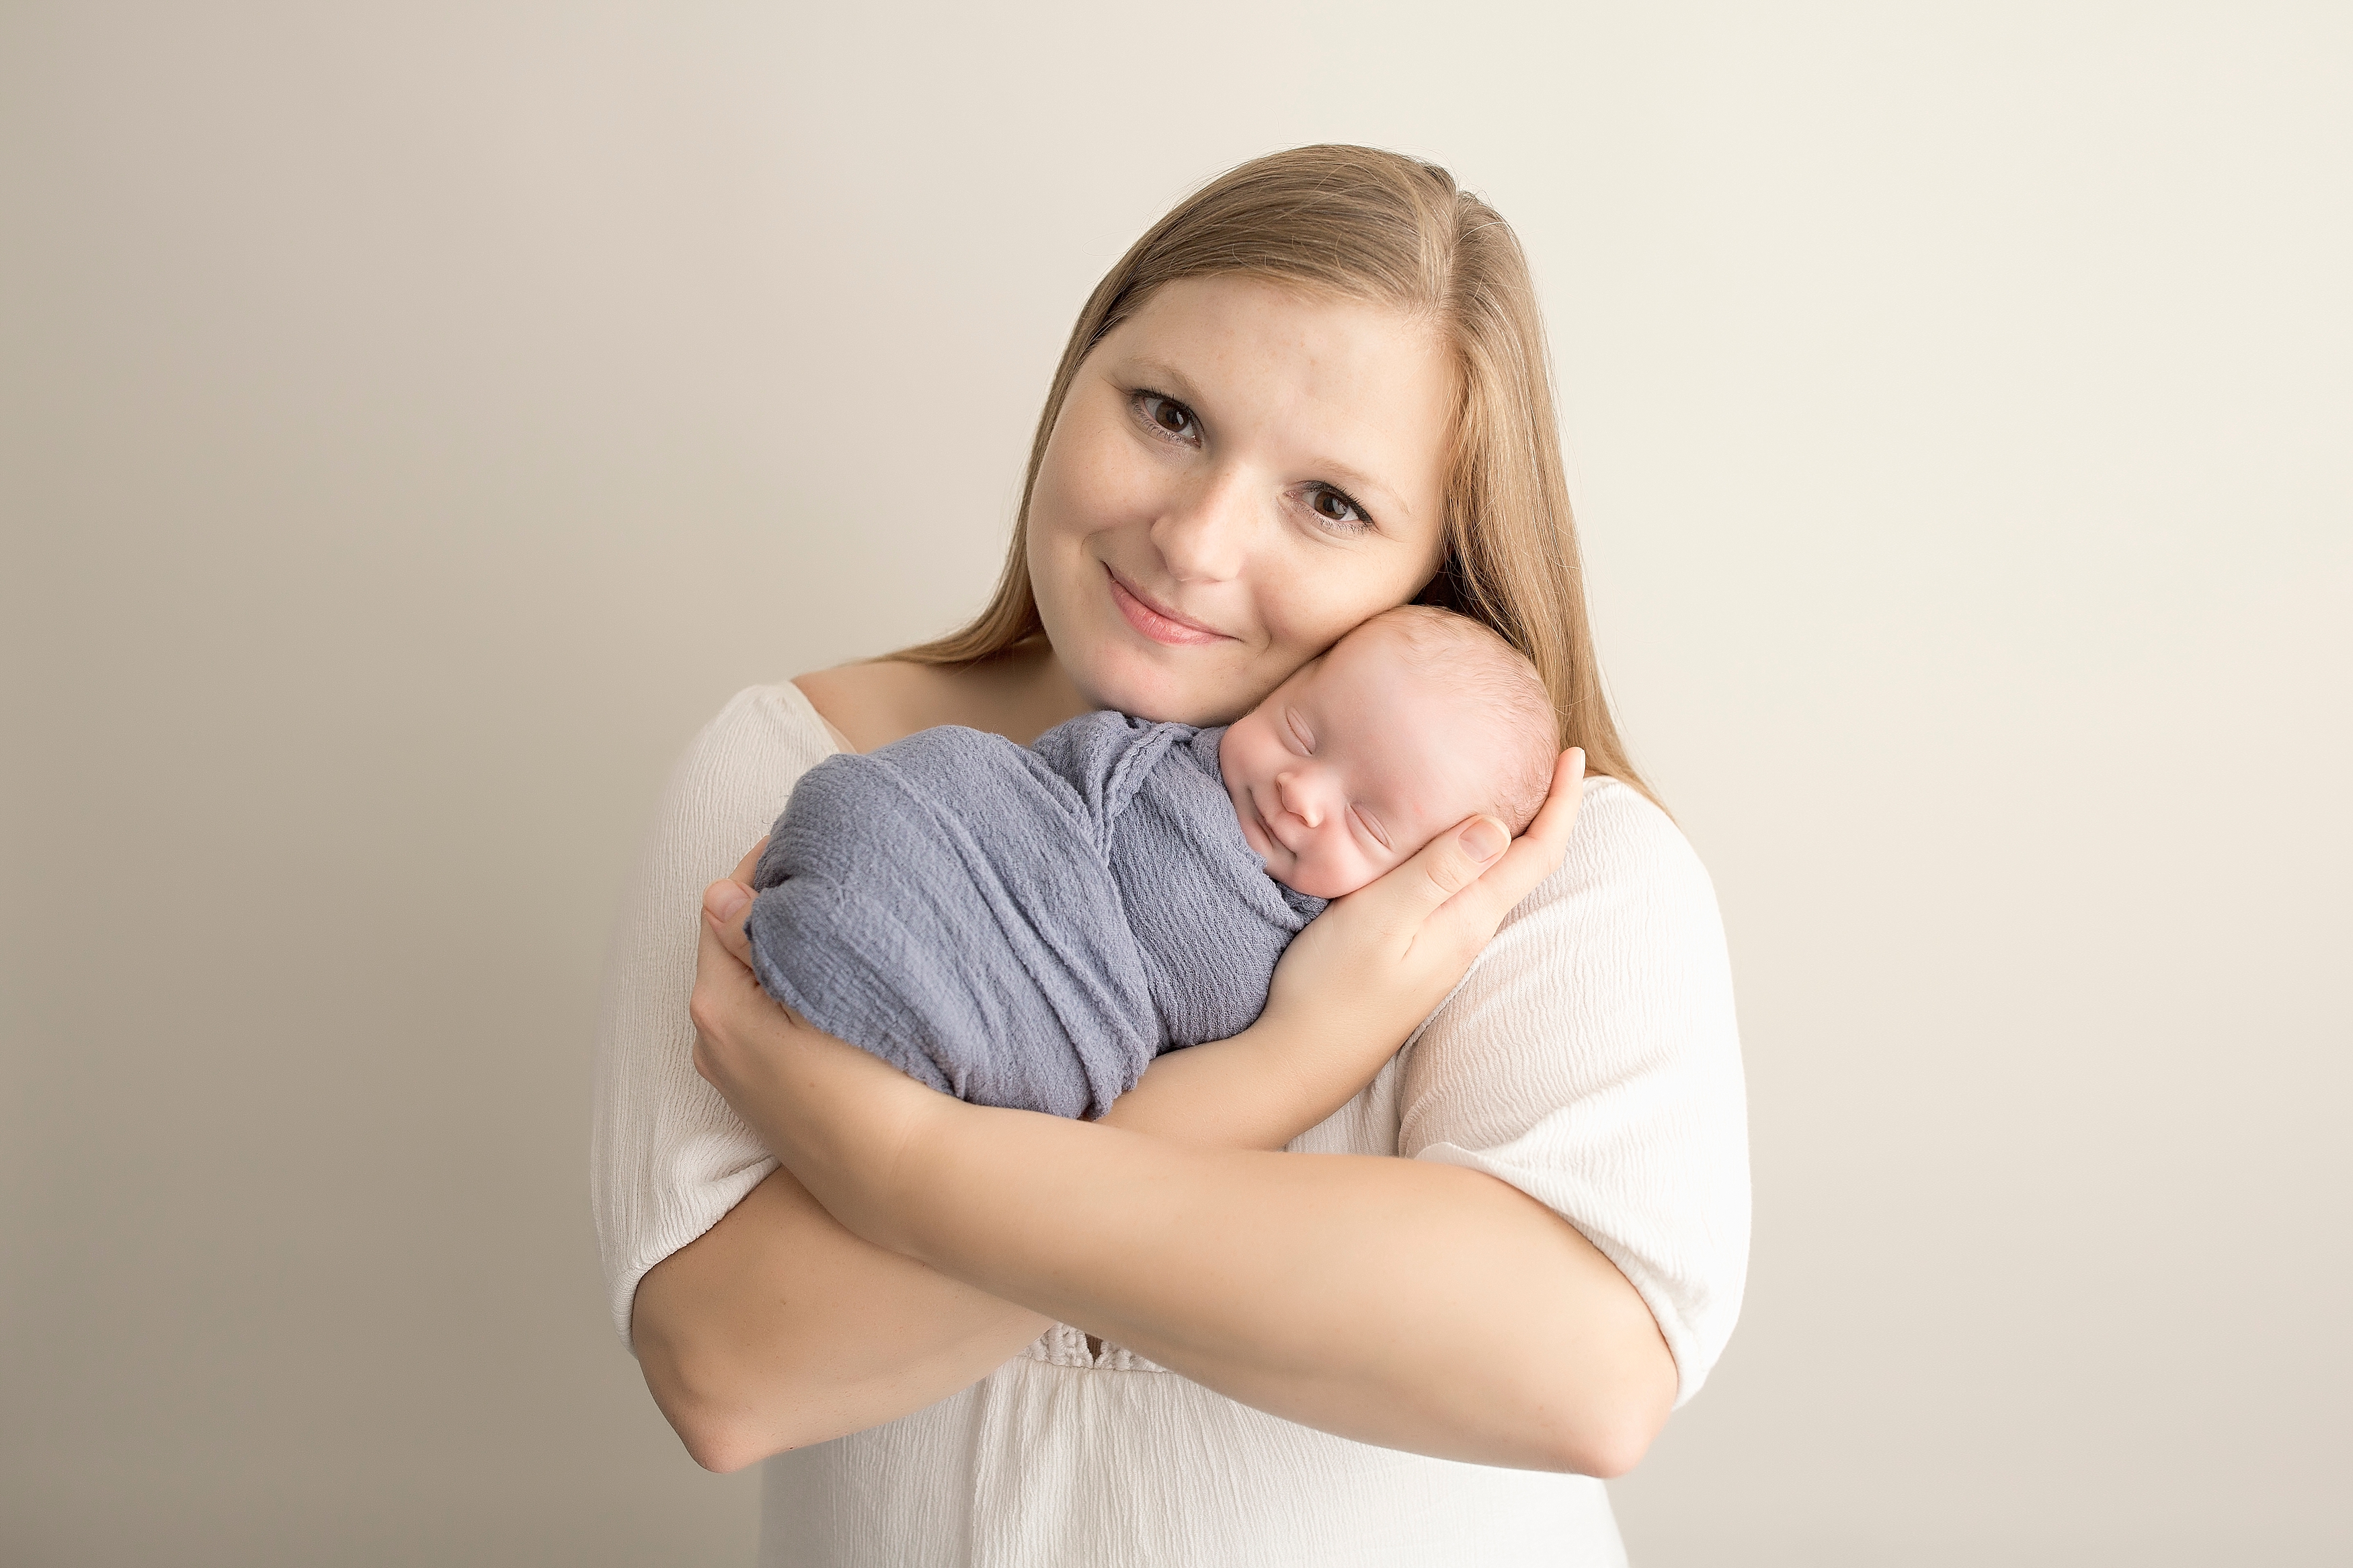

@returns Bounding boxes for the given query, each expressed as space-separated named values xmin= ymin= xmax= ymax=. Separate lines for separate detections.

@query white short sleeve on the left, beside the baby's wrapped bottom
xmin=588 ymin=684 xmax=838 ymax=1342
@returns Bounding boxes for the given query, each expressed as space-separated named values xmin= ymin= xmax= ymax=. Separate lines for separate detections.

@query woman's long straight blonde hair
xmin=889 ymin=146 xmax=1650 ymax=794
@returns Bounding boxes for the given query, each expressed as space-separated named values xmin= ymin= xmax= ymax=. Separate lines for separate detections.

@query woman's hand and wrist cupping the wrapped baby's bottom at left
xmin=687 ymin=839 xmax=958 ymax=1234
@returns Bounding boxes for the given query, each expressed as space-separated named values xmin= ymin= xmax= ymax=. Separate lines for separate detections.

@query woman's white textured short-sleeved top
xmin=593 ymin=684 xmax=1749 ymax=1568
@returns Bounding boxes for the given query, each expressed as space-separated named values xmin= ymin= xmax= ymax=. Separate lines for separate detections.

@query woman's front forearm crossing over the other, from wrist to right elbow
xmin=866 ymin=1107 xmax=1675 ymax=1474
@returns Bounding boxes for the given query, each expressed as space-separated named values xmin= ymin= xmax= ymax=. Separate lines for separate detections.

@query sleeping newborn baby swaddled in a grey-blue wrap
xmin=746 ymin=604 xmax=1556 ymax=1116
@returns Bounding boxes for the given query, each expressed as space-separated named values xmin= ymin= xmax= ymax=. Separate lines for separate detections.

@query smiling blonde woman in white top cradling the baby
xmin=596 ymin=148 xmax=1749 ymax=1566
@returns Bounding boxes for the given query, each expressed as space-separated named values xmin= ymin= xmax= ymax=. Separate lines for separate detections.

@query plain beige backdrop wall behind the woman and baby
xmin=0 ymin=0 xmax=2353 ymax=1568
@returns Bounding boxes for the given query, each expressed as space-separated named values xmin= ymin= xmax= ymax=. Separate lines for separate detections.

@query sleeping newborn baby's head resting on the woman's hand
xmin=1217 ymin=604 xmax=1556 ymax=898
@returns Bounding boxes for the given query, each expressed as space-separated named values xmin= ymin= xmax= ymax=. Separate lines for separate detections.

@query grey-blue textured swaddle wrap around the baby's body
xmin=748 ymin=712 xmax=1325 ymax=1116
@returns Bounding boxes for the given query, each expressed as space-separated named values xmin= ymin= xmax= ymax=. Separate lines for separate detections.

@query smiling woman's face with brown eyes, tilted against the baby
xmin=1029 ymin=275 xmax=1454 ymax=724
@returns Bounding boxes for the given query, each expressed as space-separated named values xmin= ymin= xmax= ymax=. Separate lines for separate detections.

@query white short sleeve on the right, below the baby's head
xmin=1398 ymin=780 xmax=1749 ymax=1406
